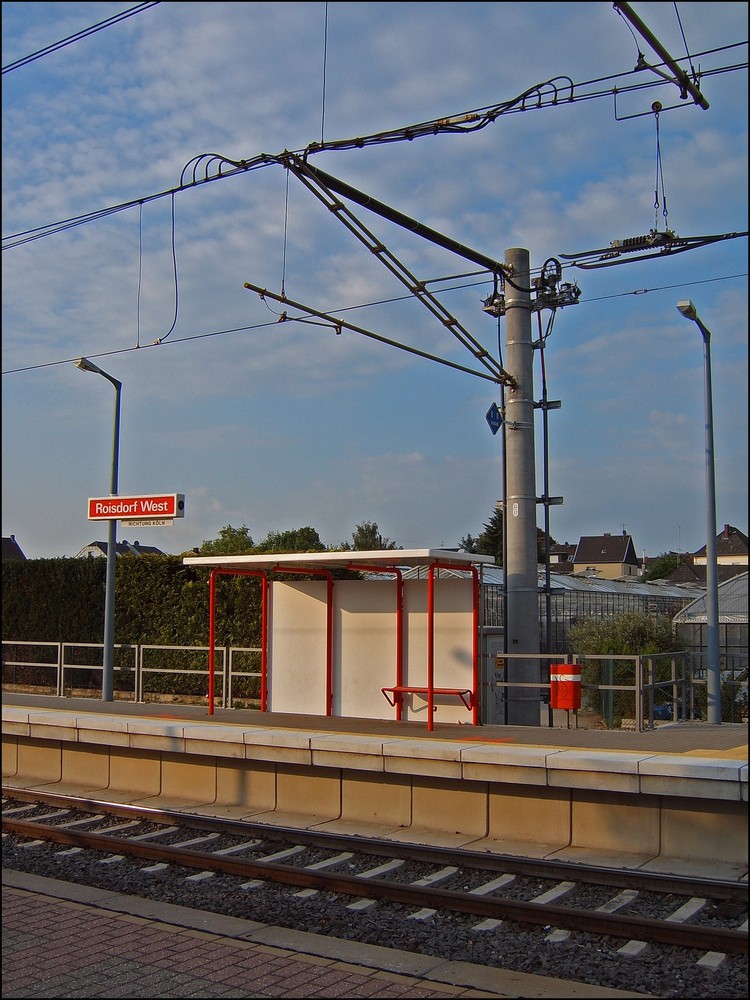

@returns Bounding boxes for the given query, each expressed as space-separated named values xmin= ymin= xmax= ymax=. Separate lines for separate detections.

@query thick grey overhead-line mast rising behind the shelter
xmin=505 ymin=248 xmax=541 ymax=726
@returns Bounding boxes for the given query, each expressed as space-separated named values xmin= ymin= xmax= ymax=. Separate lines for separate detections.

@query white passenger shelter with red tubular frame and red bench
xmin=183 ymin=549 xmax=495 ymax=730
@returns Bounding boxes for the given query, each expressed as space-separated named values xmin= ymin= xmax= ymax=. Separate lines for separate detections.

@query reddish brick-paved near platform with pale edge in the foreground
xmin=2 ymin=870 xmax=643 ymax=1000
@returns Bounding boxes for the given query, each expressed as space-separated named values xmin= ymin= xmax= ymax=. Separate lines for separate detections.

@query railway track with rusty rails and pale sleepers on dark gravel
xmin=3 ymin=789 xmax=747 ymax=996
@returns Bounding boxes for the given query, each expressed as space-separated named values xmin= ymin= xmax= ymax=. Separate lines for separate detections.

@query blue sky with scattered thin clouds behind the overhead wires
xmin=2 ymin=2 xmax=748 ymax=558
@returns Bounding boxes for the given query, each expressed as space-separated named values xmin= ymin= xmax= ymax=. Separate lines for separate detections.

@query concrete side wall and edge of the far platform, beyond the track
xmin=3 ymin=713 xmax=748 ymax=877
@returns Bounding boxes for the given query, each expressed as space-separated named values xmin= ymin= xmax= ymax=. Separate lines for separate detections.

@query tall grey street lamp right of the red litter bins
xmin=677 ymin=299 xmax=721 ymax=723
